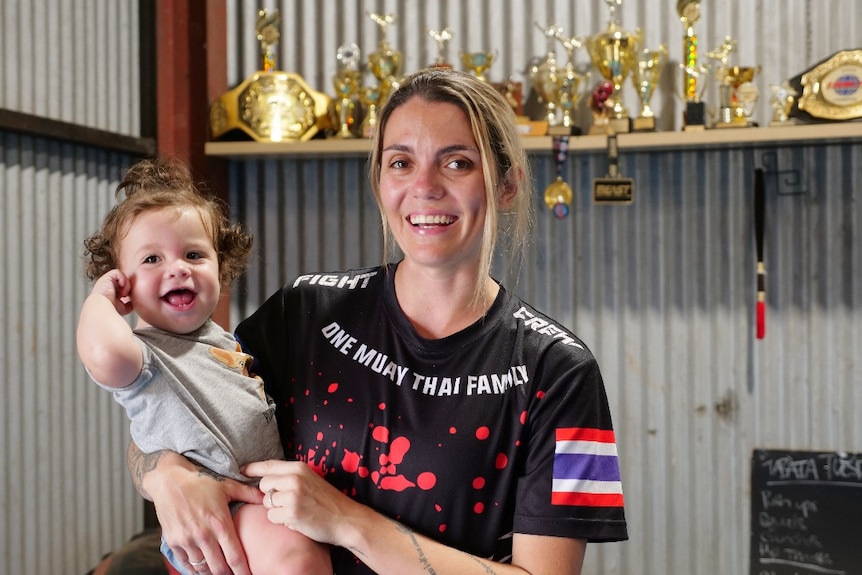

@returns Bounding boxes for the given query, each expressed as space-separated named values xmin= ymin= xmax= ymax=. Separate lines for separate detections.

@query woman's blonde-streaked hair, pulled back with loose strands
xmin=369 ymin=68 xmax=533 ymax=306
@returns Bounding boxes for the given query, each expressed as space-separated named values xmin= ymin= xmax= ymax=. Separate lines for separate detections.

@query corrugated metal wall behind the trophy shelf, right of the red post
xmin=228 ymin=0 xmax=862 ymax=575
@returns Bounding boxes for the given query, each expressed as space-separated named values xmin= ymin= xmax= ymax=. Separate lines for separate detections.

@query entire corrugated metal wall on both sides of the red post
xmin=0 ymin=0 xmax=862 ymax=575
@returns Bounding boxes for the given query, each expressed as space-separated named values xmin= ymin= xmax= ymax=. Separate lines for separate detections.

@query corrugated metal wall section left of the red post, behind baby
xmin=0 ymin=0 xmax=143 ymax=575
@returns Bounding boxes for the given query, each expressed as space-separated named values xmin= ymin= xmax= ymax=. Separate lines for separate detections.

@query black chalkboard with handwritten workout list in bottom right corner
xmin=750 ymin=449 xmax=862 ymax=575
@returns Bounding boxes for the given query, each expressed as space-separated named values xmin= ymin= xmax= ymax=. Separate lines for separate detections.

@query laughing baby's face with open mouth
xmin=118 ymin=208 xmax=221 ymax=334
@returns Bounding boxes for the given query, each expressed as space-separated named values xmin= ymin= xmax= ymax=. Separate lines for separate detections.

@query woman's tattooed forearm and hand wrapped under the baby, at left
xmin=127 ymin=442 xmax=263 ymax=575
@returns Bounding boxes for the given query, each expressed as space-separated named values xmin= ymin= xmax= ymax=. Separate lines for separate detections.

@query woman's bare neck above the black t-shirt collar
xmin=395 ymin=262 xmax=500 ymax=339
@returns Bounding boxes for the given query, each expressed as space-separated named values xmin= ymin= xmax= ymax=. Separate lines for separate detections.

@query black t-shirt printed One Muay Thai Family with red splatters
xmin=236 ymin=265 xmax=627 ymax=575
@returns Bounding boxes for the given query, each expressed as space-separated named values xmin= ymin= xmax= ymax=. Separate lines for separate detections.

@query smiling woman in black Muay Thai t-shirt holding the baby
xmin=137 ymin=70 xmax=627 ymax=575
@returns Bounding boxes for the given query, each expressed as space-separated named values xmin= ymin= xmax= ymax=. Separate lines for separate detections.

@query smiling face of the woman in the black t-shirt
xmin=380 ymin=97 xmax=487 ymax=271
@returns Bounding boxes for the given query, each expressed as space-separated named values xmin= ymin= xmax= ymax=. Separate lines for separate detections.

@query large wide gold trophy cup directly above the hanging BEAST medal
xmin=587 ymin=0 xmax=641 ymax=132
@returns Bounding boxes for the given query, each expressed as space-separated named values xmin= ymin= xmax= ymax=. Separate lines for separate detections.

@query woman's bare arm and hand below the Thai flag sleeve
xmin=244 ymin=461 xmax=586 ymax=575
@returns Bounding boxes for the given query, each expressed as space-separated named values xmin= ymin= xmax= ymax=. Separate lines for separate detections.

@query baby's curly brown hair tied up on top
xmin=84 ymin=157 xmax=253 ymax=287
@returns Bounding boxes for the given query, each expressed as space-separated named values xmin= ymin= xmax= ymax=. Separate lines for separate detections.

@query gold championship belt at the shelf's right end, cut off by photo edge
xmin=790 ymin=49 xmax=862 ymax=121
